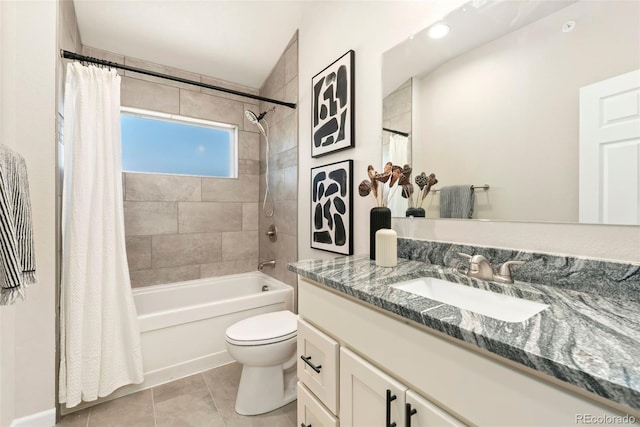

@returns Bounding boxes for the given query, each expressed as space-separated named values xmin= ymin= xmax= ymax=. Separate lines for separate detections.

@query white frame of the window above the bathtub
xmin=120 ymin=107 xmax=240 ymax=179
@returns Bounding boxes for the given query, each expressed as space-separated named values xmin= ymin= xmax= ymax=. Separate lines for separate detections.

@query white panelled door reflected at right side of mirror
xmin=580 ymin=70 xmax=640 ymax=225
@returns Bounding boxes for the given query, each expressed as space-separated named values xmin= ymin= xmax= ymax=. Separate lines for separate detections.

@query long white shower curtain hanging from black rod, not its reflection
xmin=60 ymin=63 xmax=143 ymax=407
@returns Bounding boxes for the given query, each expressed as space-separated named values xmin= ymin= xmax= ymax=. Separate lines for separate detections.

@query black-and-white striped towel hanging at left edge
xmin=0 ymin=145 xmax=37 ymax=305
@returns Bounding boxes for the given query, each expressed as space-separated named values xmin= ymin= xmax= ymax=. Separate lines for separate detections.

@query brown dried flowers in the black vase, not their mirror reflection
xmin=358 ymin=162 xmax=411 ymax=207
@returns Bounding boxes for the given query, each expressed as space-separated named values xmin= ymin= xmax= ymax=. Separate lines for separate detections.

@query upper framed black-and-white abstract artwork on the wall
xmin=311 ymin=50 xmax=356 ymax=157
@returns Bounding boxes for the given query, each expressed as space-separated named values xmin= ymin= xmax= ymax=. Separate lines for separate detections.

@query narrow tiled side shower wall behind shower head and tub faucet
xmin=259 ymin=33 xmax=298 ymax=289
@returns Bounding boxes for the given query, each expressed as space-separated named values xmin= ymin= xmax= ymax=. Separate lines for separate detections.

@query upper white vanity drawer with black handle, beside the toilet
xmin=297 ymin=319 xmax=339 ymax=414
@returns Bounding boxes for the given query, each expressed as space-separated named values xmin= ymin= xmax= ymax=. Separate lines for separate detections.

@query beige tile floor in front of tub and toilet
xmin=56 ymin=363 xmax=296 ymax=427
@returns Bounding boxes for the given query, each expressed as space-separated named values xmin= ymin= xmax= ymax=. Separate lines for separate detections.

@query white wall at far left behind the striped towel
xmin=0 ymin=1 xmax=57 ymax=427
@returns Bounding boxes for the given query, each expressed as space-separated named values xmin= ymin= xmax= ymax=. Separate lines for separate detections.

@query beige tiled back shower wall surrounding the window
xmin=83 ymin=46 xmax=260 ymax=287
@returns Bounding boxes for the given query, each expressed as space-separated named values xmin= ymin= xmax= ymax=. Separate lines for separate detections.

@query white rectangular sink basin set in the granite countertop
xmin=392 ymin=277 xmax=549 ymax=322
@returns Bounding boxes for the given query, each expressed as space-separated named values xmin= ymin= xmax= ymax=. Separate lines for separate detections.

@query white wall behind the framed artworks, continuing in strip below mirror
xmin=298 ymin=0 xmax=640 ymax=261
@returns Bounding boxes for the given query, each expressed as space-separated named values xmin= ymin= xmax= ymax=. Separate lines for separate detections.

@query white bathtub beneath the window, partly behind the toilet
xmin=62 ymin=271 xmax=293 ymax=414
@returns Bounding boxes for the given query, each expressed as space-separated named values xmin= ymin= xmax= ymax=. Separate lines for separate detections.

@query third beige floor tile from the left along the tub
xmin=153 ymin=374 xmax=224 ymax=427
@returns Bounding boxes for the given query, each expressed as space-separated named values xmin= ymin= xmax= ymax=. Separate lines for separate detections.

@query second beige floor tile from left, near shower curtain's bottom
xmin=88 ymin=390 xmax=155 ymax=427
